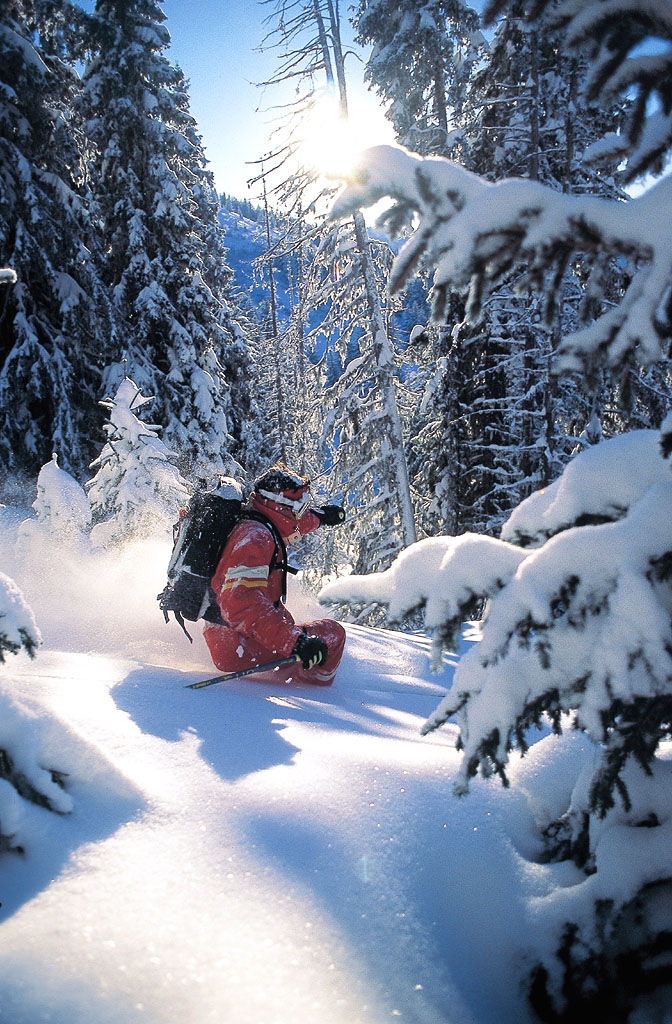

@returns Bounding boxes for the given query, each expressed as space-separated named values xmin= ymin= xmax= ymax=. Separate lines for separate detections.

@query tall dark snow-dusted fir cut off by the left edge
xmin=0 ymin=0 xmax=112 ymax=479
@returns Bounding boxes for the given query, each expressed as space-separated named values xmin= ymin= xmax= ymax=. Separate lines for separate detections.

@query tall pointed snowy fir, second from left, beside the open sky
xmin=78 ymin=0 xmax=255 ymax=480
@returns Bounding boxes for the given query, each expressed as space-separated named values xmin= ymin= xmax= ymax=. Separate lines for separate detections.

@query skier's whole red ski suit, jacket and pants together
xmin=203 ymin=497 xmax=345 ymax=686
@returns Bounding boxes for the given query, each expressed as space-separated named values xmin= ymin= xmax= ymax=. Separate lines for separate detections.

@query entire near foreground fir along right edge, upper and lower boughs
xmin=324 ymin=0 xmax=672 ymax=1022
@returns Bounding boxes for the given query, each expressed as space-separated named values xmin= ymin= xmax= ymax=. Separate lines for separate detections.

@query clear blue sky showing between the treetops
xmin=163 ymin=0 xmax=390 ymax=200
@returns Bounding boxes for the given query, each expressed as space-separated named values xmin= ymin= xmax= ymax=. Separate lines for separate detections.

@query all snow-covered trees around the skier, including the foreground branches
xmin=0 ymin=0 xmax=672 ymax=1024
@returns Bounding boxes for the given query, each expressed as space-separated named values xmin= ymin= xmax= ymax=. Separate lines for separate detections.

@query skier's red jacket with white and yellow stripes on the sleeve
xmin=212 ymin=502 xmax=321 ymax=657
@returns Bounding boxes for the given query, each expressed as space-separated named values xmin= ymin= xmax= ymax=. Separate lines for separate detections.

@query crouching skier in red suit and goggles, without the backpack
xmin=203 ymin=463 xmax=345 ymax=686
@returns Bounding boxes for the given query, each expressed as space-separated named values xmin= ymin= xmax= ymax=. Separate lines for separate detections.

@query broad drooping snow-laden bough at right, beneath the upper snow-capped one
xmin=424 ymin=481 xmax=672 ymax=785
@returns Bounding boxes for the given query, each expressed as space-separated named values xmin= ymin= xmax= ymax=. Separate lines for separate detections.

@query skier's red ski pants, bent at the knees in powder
xmin=203 ymin=618 xmax=345 ymax=686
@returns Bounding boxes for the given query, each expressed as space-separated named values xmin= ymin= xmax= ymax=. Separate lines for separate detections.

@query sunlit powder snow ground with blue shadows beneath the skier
xmin=0 ymin=514 xmax=594 ymax=1024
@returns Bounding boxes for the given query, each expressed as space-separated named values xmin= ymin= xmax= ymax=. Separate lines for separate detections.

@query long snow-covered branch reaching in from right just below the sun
xmin=332 ymin=146 xmax=672 ymax=373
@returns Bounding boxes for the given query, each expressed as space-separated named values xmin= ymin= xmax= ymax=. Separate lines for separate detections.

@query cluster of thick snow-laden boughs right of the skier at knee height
xmin=320 ymin=430 xmax=672 ymax=810
